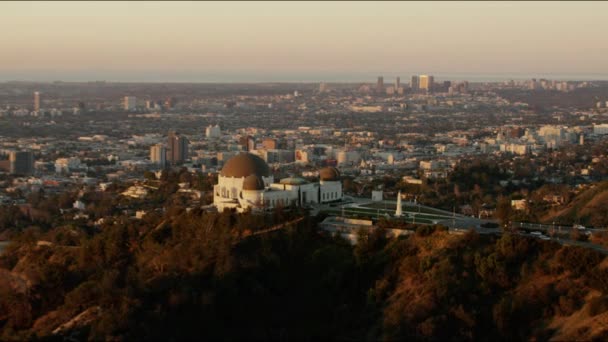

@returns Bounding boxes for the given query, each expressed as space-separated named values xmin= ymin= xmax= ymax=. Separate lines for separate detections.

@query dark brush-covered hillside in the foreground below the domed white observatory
xmin=0 ymin=210 xmax=608 ymax=341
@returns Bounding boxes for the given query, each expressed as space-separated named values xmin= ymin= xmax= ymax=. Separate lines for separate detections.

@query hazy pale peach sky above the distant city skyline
xmin=0 ymin=2 xmax=608 ymax=81
